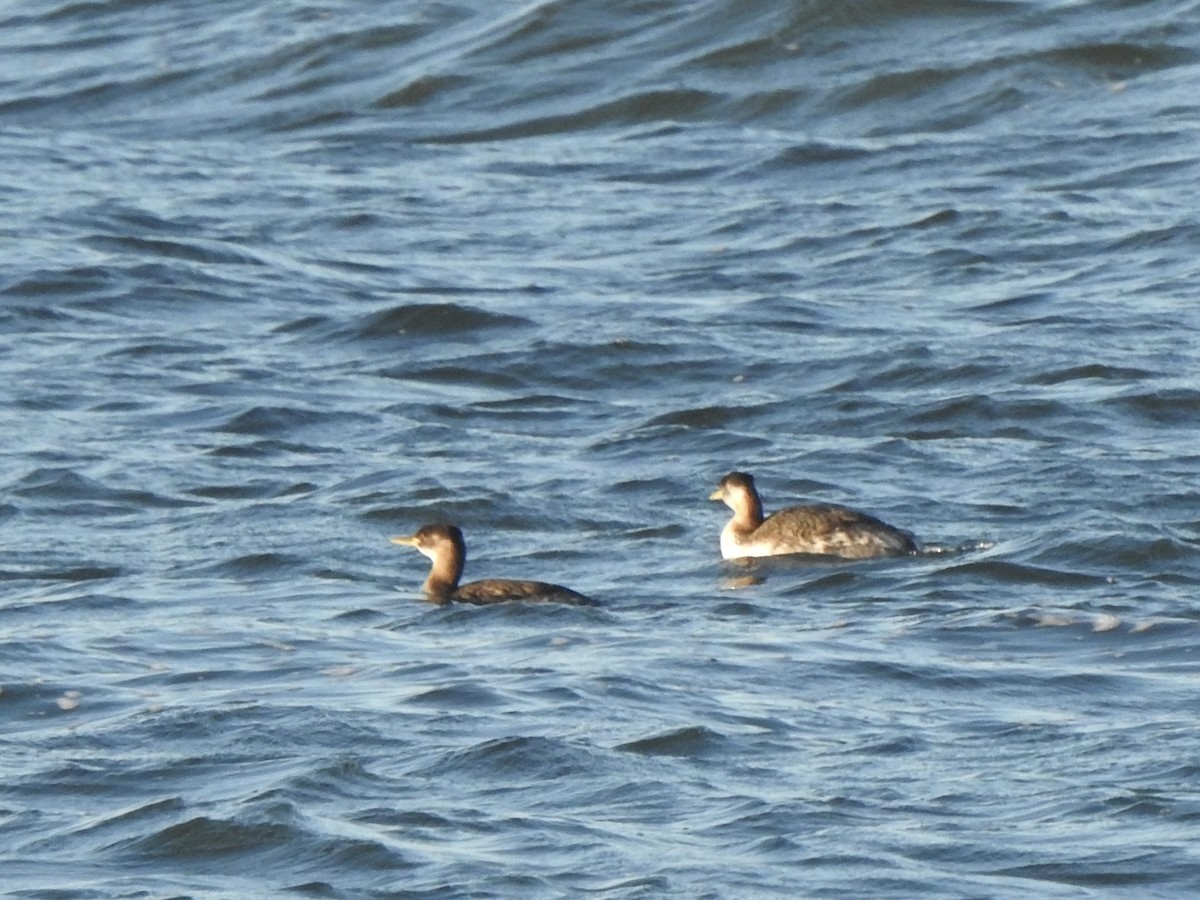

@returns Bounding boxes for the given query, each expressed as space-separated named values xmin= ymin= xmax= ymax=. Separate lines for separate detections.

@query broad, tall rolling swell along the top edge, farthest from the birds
xmin=0 ymin=0 xmax=1196 ymax=143
